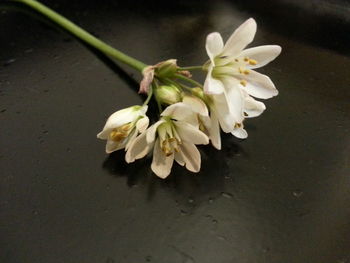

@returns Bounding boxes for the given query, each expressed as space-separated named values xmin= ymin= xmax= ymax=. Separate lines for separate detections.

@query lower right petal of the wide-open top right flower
xmin=242 ymin=70 xmax=278 ymax=99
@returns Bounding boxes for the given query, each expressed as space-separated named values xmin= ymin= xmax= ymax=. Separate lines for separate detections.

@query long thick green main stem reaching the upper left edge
xmin=13 ymin=0 xmax=147 ymax=72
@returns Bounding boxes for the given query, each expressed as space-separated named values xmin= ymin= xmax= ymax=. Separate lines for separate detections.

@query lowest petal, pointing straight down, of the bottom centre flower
xmin=151 ymin=139 xmax=174 ymax=179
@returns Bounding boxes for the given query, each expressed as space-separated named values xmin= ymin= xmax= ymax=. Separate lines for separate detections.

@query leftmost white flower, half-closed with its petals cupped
xmin=97 ymin=105 xmax=149 ymax=153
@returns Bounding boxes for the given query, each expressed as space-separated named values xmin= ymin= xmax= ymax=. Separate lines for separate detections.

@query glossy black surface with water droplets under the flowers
xmin=0 ymin=0 xmax=350 ymax=263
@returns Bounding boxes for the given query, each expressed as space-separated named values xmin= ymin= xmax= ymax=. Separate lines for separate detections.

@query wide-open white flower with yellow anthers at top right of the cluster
xmin=204 ymin=18 xmax=281 ymax=99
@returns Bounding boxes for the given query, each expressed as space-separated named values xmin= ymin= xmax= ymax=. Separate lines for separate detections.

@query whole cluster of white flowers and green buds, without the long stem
xmin=97 ymin=18 xmax=281 ymax=178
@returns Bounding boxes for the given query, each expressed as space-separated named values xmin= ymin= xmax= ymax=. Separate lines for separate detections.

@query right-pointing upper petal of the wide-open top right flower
xmin=240 ymin=45 xmax=281 ymax=69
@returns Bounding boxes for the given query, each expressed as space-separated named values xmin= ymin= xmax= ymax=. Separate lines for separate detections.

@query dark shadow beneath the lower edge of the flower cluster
xmin=102 ymin=134 xmax=247 ymax=205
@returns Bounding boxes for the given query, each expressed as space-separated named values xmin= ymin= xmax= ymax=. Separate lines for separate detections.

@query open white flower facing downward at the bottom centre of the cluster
xmin=125 ymin=102 xmax=209 ymax=178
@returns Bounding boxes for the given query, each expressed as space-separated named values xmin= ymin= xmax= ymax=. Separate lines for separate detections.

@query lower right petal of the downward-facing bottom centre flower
xmin=179 ymin=143 xmax=201 ymax=173
